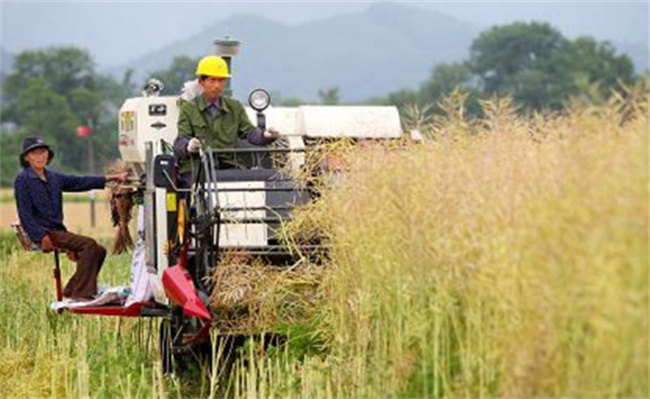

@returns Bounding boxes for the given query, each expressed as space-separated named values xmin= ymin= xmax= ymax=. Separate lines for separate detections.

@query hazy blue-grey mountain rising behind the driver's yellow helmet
xmin=110 ymin=3 xmax=479 ymax=101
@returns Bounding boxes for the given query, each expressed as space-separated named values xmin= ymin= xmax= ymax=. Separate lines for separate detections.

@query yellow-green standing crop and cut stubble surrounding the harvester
xmin=0 ymin=93 xmax=650 ymax=398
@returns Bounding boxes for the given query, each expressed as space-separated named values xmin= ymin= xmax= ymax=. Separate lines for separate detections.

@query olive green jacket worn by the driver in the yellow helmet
xmin=174 ymin=96 xmax=255 ymax=172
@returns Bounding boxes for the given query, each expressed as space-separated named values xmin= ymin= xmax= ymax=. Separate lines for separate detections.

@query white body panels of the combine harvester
xmin=118 ymin=96 xmax=402 ymax=275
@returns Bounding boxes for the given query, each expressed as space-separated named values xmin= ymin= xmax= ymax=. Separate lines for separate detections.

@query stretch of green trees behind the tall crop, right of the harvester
xmin=376 ymin=22 xmax=638 ymax=115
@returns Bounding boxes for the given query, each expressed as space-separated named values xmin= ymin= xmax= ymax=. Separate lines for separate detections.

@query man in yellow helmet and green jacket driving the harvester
xmin=174 ymin=55 xmax=279 ymax=184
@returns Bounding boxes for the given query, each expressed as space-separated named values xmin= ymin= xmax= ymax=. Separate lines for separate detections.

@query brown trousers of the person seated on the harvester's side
xmin=48 ymin=231 xmax=106 ymax=299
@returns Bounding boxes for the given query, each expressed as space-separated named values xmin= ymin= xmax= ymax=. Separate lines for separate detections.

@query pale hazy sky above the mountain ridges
xmin=0 ymin=0 xmax=649 ymax=66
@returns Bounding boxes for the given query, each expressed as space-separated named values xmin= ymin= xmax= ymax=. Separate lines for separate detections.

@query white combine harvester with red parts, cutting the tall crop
xmin=39 ymin=39 xmax=402 ymax=371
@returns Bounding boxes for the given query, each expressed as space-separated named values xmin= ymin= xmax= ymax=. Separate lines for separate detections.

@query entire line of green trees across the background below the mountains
xmin=0 ymin=22 xmax=647 ymax=186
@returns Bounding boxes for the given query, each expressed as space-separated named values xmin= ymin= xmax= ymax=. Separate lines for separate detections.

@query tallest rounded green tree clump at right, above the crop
xmin=467 ymin=22 xmax=634 ymax=110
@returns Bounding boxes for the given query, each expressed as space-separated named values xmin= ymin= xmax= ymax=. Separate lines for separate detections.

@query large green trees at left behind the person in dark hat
xmin=0 ymin=47 xmax=132 ymax=185
